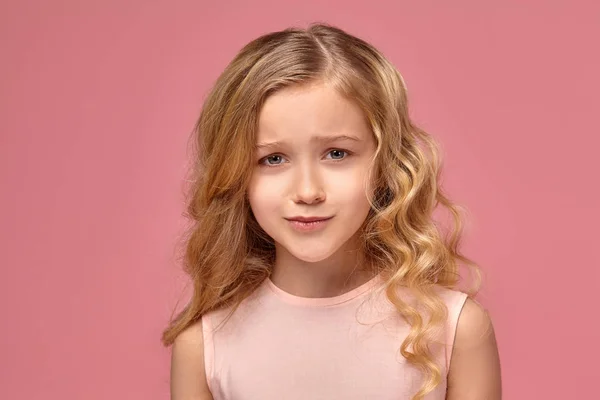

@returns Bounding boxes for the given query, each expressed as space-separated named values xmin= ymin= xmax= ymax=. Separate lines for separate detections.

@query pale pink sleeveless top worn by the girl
xmin=202 ymin=275 xmax=467 ymax=400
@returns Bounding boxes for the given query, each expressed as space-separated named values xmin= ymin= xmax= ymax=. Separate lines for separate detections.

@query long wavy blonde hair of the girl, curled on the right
xmin=162 ymin=24 xmax=479 ymax=399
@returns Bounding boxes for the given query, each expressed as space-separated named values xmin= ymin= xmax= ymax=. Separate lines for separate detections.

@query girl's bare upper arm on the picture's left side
xmin=171 ymin=321 xmax=212 ymax=400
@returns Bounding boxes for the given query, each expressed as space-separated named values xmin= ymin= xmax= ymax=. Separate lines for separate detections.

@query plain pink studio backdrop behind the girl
xmin=0 ymin=0 xmax=600 ymax=400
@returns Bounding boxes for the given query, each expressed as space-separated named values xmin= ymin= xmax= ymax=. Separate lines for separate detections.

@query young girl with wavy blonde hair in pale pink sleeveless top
xmin=163 ymin=24 xmax=501 ymax=400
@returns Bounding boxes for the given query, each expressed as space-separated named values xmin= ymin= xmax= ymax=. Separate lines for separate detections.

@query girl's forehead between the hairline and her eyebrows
xmin=257 ymin=83 xmax=371 ymax=142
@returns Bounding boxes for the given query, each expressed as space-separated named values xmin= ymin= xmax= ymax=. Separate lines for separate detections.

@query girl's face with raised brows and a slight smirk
xmin=248 ymin=83 xmax=376 ymax=262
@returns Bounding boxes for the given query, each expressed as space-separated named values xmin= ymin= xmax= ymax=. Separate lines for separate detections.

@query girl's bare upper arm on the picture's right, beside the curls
xmin=446 ymin=299 xmax=502 ymax=400
